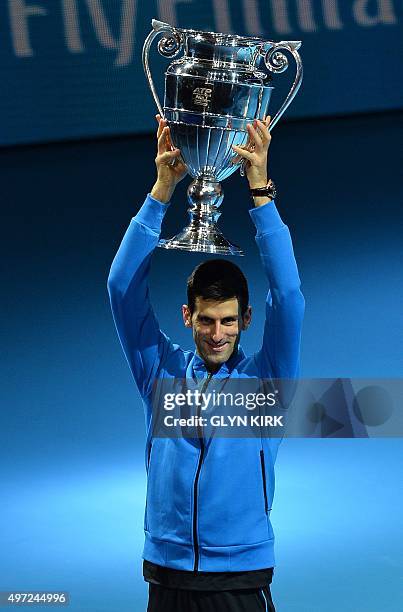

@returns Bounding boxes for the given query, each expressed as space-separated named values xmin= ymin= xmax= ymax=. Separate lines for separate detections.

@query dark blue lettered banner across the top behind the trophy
xmin=0 ymin=0 xmax=403 ymax=145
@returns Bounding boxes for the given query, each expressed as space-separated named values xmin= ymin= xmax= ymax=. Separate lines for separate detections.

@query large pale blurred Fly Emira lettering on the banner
xmin=8 ymin=0 xmax=398 ymax=67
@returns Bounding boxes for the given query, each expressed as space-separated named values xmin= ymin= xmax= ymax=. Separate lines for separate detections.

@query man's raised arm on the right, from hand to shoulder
xmin=234 ymin=117 xmax=305 ymax=378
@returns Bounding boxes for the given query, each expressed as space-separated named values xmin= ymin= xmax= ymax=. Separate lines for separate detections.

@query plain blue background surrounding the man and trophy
xmin=0 ymin=0 xmax=403 ymax=612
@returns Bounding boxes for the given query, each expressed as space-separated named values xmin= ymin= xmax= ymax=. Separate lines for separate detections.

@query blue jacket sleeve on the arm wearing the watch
xmin=249 ymin=201 xmax=305 ymax=378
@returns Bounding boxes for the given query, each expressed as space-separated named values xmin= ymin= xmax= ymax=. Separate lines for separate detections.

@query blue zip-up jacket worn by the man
xmin=108 ymin=195 xmax=304 ymax=572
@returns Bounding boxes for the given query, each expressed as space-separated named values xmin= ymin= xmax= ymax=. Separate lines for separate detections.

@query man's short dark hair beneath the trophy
xmin=187 ymin=259 xmax=249 ymax=316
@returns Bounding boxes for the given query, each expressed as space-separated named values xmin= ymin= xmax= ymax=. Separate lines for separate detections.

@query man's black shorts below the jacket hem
xmin=147 ymin=583 xmax=275 ymax=612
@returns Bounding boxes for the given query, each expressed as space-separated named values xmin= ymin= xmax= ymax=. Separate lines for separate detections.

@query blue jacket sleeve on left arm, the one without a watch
xmin=108 ymin=195 xmax=173 ymax=398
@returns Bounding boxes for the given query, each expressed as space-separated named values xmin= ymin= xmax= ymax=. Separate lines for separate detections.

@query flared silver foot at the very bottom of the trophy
xmin=157 ymin=225 xmax=244 ymax=257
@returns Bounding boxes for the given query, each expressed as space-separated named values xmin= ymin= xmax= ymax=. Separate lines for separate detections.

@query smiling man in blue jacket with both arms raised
xmin=108 ymin=115 xmax=304 ymax=612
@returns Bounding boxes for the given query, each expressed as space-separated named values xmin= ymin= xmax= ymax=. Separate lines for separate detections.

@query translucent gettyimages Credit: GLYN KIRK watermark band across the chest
xmin=151 ymin=377 xmax=403 ymax=438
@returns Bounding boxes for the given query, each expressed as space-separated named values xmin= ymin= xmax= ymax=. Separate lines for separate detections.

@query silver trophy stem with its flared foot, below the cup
xmin=158 ymin=175 xmax=244 ymax=255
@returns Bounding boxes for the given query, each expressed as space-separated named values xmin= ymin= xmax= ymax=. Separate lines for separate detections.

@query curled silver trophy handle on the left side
xmin=142 ymin=19 xmax=183 ymax=117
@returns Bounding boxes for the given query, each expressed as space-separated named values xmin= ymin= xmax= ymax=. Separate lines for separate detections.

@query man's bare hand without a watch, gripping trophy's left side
xmin=151 ymin=115 xmax=187 ymax=203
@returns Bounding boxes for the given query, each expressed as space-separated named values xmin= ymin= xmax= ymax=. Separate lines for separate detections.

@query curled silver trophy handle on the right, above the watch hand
xmin=260 ymin=40 xmax=303 ymax=130
